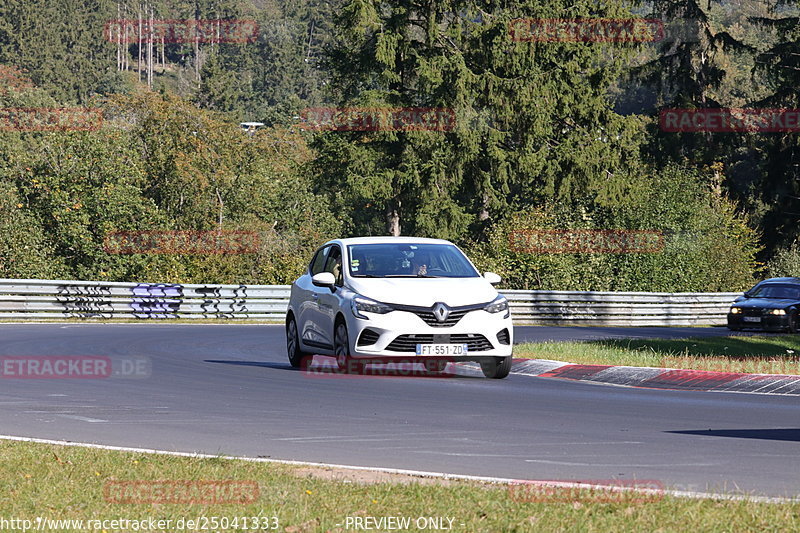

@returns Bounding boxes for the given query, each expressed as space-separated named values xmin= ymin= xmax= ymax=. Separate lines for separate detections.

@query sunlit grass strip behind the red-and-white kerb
xmin=514 ymin=335 xmax=800 ymax=375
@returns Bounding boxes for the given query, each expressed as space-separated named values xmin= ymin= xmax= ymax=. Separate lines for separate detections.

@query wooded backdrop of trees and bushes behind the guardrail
xmin=0 ymin=0 xmax=800 ymax=290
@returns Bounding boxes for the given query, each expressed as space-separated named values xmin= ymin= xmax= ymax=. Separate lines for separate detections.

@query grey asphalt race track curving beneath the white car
xmin=0 ymin=324 xmax=800 ymax=496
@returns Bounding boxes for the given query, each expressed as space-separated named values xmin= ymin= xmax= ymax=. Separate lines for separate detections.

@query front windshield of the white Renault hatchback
xmin=348 ymin=243 xmax=479 ymax=278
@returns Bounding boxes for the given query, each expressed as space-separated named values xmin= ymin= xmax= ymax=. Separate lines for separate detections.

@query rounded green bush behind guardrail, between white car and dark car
xmin=471 ymin=167 xmax=759 ymax=292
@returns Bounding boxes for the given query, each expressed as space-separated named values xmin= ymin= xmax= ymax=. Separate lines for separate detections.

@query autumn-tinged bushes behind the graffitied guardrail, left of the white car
xmin=0 ymin=89 xmax=340 ymax=284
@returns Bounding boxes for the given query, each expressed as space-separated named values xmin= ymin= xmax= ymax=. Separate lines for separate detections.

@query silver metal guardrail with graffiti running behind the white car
xmin=0 ymin=279 xmax=741 ymax=326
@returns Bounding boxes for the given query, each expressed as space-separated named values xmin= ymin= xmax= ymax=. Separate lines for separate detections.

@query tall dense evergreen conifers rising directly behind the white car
xmin=314 ymin=0 xmax=641 ymax=238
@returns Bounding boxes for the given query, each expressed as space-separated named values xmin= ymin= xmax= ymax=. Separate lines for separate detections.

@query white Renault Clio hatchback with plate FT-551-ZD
xmin=286 ymin=237 xmax=514 ymax=378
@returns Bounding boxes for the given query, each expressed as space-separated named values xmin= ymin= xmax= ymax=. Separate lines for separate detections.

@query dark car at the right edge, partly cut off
xmin=728 ymin=278 xmax=800 ymax=333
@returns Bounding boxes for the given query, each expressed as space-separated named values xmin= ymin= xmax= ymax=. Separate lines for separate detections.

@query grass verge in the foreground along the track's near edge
xmin=0 ymin=441 xmax=800 ymax=533
